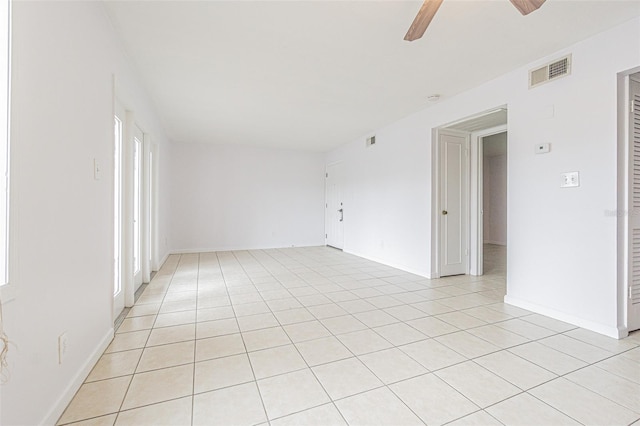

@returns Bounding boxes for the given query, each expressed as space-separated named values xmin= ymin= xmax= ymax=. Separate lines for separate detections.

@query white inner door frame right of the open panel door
xmin=469 ymin=124 xmax=509 ymax=276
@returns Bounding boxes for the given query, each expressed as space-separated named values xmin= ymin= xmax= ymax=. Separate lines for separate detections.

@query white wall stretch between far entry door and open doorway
xmin=327 ymin=120 xmax=431 ymax=275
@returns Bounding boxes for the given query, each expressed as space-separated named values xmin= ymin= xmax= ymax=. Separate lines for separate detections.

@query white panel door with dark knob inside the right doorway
xmin=438 ymin=130 xmax=469 ymax=277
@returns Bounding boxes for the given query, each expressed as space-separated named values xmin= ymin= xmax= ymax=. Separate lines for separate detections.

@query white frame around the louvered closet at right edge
xmin=615 ymin=67 xmax=640 ymax=338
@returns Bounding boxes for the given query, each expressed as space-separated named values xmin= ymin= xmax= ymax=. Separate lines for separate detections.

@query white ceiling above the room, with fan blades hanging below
xmin=105 ymin=0 xmax=640 ymax=151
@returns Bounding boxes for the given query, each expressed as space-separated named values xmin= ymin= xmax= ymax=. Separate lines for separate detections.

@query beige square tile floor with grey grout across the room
xmin=59 ymin=246 xmax=640 ymax=426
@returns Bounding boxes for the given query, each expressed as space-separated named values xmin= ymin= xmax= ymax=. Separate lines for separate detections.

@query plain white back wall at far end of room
xmin=171 ymin=143 xmax=324 ymax=252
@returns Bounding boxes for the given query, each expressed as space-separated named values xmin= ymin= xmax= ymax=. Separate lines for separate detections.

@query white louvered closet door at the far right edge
xmin=628 ymin=80 xmax=640 ymax=331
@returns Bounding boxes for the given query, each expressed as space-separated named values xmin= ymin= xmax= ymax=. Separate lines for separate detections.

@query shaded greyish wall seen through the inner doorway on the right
xmin=482 ymin=133 xmax=507 ymax=245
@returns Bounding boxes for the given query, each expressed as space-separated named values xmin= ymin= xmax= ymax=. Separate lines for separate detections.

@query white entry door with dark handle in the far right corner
xmin=325 ymin=163 xmax=344 ymax=250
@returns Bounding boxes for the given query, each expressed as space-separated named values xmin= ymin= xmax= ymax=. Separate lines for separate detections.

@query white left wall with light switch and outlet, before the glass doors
xmin=0 ymin=1 xmax=168 ymax=425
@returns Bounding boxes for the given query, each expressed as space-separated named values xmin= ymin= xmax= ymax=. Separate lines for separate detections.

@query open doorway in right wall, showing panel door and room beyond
xmin=431 ymin=106 xmax=508 ymax=278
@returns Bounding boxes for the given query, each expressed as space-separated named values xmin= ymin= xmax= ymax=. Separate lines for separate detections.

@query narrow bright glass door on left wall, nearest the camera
xmin=113 ymin=105 xmax=126 ymax=320
